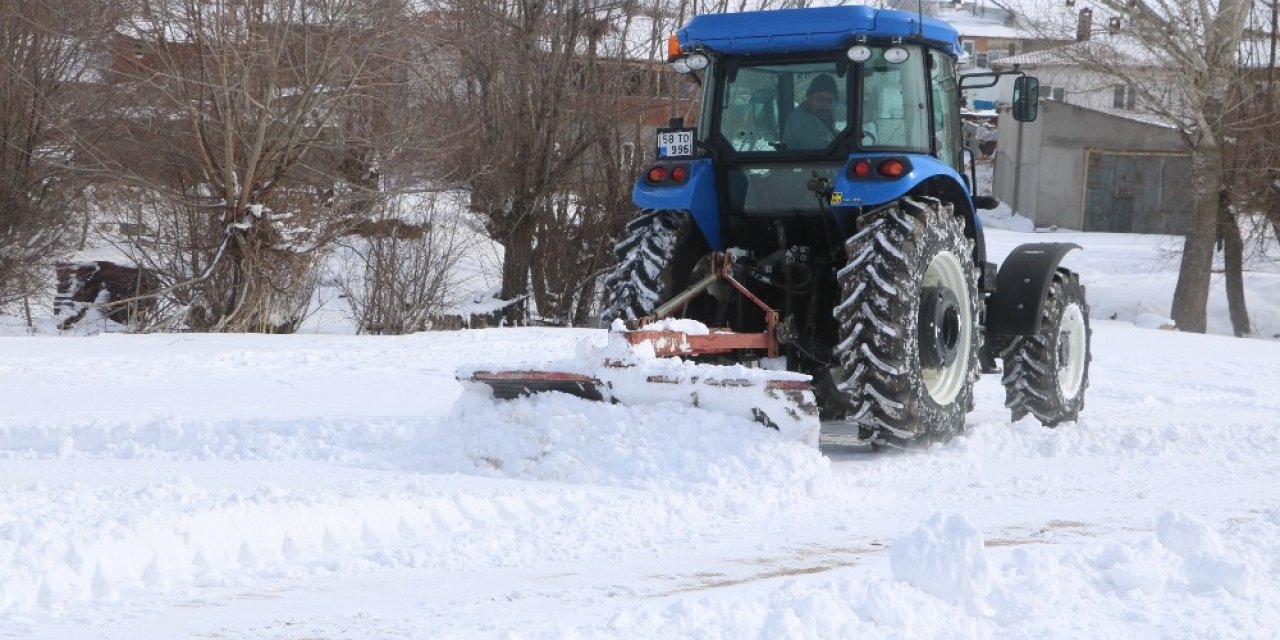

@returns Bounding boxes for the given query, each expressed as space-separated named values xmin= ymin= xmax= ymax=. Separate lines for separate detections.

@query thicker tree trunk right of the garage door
xmin=1170 ymin=145 xmax=1222 ymax=333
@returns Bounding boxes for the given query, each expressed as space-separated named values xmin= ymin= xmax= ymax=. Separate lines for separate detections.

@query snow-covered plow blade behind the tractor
xmin=457 ymin=335 xmax=819 ymax=445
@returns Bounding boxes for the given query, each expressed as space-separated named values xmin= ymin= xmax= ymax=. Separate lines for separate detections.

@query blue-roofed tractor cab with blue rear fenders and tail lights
xmin=634 ymin=6 xmax=1037 ymax=247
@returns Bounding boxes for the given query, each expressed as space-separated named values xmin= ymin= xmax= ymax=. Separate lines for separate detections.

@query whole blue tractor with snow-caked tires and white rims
xmin=593 ymin=6 xmax=1091 ymax=447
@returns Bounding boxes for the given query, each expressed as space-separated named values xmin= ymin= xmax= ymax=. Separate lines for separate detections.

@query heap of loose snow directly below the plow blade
xmin=408 ymin=393 xmax=831 ymax=511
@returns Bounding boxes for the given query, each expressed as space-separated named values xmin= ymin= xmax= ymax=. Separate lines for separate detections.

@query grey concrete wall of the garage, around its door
xmin=992 ymin=101 xmax=1185 ymax=229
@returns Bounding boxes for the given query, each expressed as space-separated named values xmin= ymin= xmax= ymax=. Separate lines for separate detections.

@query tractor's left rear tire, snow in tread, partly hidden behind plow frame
xmin=600 ymin=209 xmax=692 ymax=328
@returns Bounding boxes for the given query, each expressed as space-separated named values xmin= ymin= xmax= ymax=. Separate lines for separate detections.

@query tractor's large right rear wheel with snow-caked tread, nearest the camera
xmin=835 ymin=197 xmax=982 ymax=447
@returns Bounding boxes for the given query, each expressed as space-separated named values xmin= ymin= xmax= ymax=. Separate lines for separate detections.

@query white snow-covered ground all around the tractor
xmin=0 ymin=228 xmax=1280 ymax=640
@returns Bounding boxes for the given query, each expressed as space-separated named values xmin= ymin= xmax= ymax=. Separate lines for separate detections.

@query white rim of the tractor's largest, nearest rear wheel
xmin=918 ymin=251 xmax=974 ymax=404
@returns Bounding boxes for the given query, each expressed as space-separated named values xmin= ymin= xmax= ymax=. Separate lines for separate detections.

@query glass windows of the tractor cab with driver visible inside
xmin=698 ymin=44 xmax=961 ymax=218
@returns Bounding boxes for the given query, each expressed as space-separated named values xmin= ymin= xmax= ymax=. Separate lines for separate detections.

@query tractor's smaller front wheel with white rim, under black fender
xmin=1001 ymin=269 xmax=1093 ymax=426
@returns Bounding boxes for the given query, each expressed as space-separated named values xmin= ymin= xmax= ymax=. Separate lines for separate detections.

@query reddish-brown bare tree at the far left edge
xmin=0 ymin=0 xmax=114 ymax=306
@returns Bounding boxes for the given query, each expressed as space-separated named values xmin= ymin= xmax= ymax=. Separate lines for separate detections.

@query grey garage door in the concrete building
xmin=1084 ymin=150 xmax=1192 ymax=236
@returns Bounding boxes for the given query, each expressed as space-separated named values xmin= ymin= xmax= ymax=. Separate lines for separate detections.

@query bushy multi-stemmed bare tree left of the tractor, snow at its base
xmin=111 ymin=0 xmax=406 ymax=332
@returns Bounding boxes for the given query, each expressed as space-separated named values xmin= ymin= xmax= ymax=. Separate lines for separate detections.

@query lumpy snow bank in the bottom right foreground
xmin=521 ymin=512 xmax=1280 ymax=640
